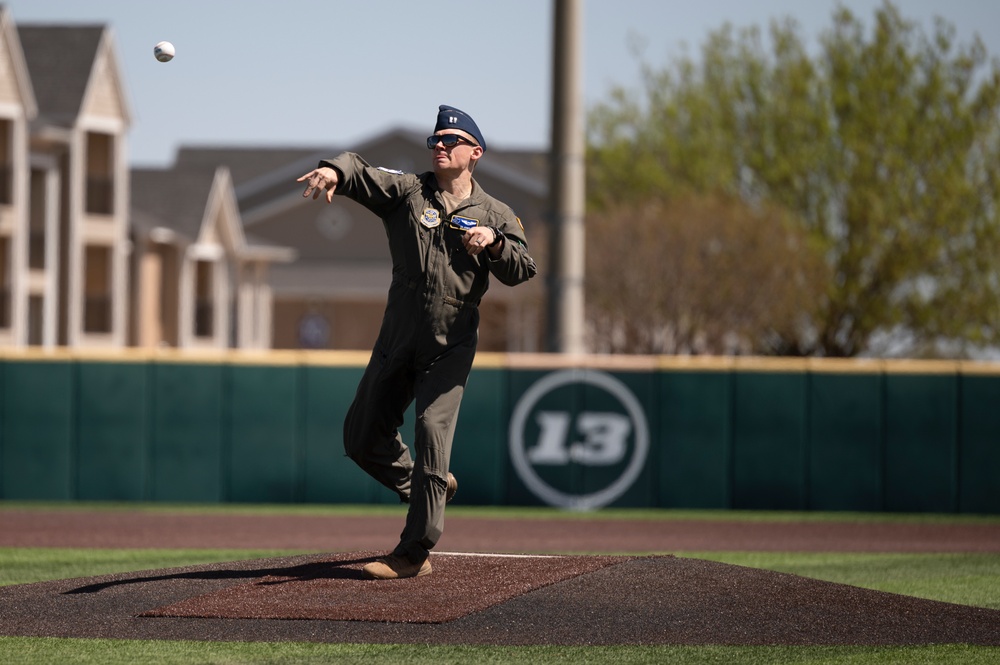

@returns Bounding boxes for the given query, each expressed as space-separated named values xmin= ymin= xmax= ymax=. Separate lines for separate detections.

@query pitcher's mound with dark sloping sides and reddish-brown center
xmin=0 ymin=552 xmax=1000 ymax=645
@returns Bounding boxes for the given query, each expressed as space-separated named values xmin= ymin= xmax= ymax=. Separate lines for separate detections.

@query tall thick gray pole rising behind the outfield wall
xmin=547 ymin=0 xmax=585 ymax=354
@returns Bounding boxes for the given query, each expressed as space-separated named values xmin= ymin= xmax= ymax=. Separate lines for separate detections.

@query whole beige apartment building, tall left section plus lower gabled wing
xmin=0 ymin=6 xmax=294 ymax=349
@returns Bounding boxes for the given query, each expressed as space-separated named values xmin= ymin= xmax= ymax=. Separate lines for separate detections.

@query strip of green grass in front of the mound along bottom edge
xmin=0 ymin=637 xmax=998 ymax=665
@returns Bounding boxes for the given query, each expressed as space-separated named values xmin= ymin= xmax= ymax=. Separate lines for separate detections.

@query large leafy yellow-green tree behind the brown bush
xmin=588 ymin=2 xmax=1000 ymax=356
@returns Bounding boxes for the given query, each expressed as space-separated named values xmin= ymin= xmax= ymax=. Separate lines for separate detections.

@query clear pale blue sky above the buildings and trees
xmin=3 ymin=0 xmax=1000 ymax=166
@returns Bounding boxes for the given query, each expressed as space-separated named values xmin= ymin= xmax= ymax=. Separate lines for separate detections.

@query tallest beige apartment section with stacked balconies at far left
xmin=0 ymin=15 xmax=130 ymax=347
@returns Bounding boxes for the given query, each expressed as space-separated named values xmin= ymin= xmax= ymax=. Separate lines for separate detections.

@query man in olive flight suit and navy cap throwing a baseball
xmin=298 ymin=106 xmax=536 ymax=580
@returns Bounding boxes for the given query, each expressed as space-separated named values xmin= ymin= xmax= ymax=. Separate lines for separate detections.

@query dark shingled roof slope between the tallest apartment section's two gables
xmin=18 ymin=25 xmax=105 ymax=127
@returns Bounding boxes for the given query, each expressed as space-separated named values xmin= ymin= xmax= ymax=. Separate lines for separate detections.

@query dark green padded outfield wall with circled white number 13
xmin=0 ymin=352 xmax=1000 ymax=513
